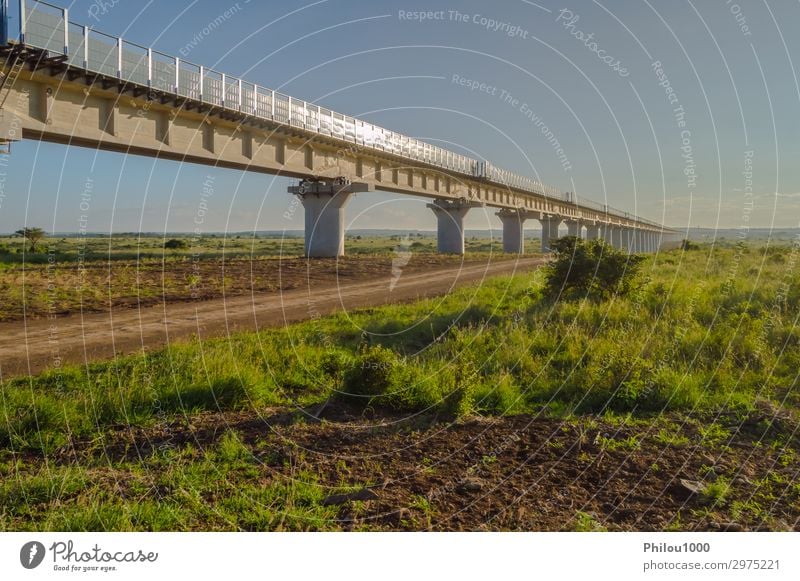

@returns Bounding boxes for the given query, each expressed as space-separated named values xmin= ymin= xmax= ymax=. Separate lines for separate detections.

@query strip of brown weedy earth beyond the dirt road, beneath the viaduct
xmin=0 ymin=252 xmax=488 ymax=322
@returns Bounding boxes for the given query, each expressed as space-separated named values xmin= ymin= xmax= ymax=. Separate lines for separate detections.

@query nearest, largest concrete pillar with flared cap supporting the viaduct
xmin=289 ymin=178 xmax=370 ymax=258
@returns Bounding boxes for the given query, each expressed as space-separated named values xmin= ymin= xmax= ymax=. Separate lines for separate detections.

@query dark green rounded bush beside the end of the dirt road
xmin=545 ymin=236 xmax=644 ymax=299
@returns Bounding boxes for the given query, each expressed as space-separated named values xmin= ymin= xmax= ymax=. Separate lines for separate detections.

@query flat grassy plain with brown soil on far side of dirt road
xmin=0 ymin=234 xmax=499 ymax=322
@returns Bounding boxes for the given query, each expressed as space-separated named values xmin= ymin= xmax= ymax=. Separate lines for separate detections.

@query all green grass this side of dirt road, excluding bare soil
xmin=0 ymin=241 xmax=800 ymax=530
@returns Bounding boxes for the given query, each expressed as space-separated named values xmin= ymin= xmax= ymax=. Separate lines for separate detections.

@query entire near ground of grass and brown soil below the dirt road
xmin=0 ymin=237 xmax=800 ymax=531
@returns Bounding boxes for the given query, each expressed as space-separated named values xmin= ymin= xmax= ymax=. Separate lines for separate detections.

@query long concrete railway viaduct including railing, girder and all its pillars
xmin=0 ymin=0 xmax=672 ymax=257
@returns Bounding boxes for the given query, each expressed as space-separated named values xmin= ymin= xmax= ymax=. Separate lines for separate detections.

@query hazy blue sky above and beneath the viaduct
xmin=0 ymin=0 xmax=800 ymax=232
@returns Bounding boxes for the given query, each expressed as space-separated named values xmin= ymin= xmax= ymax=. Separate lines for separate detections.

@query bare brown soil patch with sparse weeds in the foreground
xmin=57 ymin=404 xmax=800 ymax=531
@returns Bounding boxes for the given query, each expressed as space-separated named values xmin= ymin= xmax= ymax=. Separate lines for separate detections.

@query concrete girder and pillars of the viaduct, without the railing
xmin=0 ymin=52 xmax=662 ymax=256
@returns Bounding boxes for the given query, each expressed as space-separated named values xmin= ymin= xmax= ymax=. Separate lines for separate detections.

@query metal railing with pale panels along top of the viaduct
xmin=0 ymin=0 xmax=660 ymax=227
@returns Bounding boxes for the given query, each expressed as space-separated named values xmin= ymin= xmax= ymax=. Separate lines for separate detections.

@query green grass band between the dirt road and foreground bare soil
xmin=0 ymin=241 xmax=800 ymax=453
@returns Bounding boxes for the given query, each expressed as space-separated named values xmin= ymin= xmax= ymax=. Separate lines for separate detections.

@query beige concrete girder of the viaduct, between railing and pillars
xmin=0 ymin=65 xmax=672 ymax=231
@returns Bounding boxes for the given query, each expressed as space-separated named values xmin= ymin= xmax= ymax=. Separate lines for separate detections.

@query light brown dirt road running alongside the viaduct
xmin=0 ymin=258 xmax=544 ymax=379
